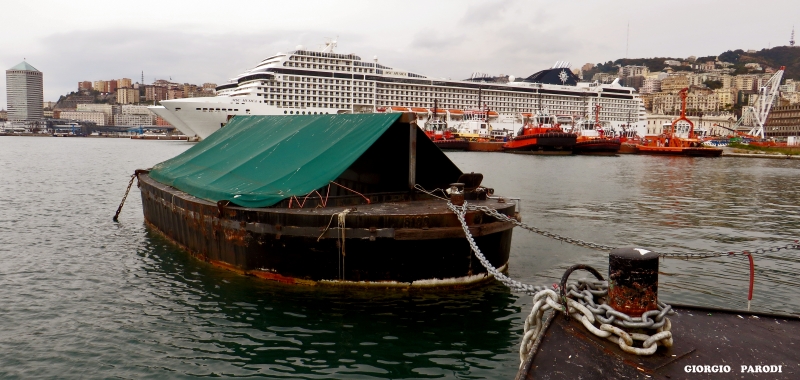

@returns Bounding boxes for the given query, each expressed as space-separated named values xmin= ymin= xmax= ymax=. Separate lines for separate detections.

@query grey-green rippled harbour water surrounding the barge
xmin=0 ymin=137 xmax=800 ymax=379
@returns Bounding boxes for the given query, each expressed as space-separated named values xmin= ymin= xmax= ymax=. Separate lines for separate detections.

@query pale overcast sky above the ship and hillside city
xmin=0 ymin=0 xmax=800 ymax=108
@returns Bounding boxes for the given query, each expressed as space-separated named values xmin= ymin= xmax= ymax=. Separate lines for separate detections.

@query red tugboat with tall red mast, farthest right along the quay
xmin=636 ymin=88 xmax=722 ymax=157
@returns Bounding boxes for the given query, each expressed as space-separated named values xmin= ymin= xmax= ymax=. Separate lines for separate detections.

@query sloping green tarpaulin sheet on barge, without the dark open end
xmin=150 ymin=113 xmax=401 ymax=207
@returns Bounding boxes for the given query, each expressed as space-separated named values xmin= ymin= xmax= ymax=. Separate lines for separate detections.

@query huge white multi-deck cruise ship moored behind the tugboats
xmin=151 ymin=41 xmax=646 ymax=139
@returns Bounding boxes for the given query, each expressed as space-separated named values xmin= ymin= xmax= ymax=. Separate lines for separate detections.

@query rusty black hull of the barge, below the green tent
xmin=139 ymin=173 xmax=515 ymax=287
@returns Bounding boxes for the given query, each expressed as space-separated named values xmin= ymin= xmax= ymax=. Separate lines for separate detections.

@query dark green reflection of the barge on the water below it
xmin=124 ymin=230 xmax=521 ymax=378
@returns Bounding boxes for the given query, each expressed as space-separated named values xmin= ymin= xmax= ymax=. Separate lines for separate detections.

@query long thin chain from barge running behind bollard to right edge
xmin=466 ymin=205 xmax=800 ymax=260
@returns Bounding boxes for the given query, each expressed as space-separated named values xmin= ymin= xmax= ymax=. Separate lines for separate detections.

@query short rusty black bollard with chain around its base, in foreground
xmin=608 ymin=248 xmax=658 ymax=317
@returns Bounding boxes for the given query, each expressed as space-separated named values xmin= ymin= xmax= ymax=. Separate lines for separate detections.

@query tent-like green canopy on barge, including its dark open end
xmin=150 ymin=113 xmax=461 ymax=207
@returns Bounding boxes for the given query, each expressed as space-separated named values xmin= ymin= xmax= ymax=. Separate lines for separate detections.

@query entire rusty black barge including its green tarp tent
xmin=138 ymin=114 xmax=517 ymax=288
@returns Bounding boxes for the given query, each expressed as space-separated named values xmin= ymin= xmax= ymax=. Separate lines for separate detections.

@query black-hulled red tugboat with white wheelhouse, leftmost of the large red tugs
xmin=503 ymin=112 xmax=578 ymax=154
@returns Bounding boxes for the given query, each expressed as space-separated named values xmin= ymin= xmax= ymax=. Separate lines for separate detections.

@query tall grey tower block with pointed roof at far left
xmin=6 ymin=61 xmax=44 ymax=123
